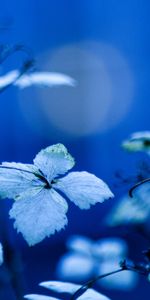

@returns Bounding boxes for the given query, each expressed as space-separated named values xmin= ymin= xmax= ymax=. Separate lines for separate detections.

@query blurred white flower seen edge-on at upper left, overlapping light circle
xmin=0 ymin=70 xmax=76 ymax=89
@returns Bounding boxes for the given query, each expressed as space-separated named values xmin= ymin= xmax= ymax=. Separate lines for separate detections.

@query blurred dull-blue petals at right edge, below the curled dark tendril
xmin=106 ymin=182 xmax=150 ymax=226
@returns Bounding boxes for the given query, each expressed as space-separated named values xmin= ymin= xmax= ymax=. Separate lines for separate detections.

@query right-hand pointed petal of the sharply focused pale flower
xmin=53 ymin=172 xmax=114 ymax=209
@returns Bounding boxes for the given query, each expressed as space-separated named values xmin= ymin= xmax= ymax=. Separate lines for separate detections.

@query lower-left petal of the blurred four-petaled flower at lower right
xmin=56 ymin=253 xmax=95 ymax=282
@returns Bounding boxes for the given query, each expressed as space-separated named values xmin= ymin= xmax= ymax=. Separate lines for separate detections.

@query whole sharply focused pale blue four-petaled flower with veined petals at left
xmin=0 ymin=144 xmax=113 ymax=245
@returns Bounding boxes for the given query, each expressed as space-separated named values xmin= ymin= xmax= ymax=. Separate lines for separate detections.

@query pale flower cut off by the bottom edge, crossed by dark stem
xmin=24 ymin=281 xmax=110 ymax=300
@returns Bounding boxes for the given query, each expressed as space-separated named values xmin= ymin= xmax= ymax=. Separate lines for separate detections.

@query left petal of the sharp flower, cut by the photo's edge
xmin=0 ymin=162 xmax=44 ymax=199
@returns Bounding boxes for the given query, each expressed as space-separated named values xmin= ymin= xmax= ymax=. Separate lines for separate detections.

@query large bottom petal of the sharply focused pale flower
xmin=10 ymin=189 xmax=68 ymax=246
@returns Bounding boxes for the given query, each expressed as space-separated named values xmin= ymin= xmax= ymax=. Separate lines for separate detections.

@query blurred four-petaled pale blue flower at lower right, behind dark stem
xmin=56 ymin=236 xmax=138 ymax=290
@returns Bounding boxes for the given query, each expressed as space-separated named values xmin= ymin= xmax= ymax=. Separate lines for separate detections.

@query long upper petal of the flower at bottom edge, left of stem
xmin=39 ymin=281 xmax=81 ymax=294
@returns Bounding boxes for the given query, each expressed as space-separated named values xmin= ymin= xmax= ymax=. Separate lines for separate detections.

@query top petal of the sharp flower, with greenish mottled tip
xmin=34 ymin=144 xmax=75 ymax=182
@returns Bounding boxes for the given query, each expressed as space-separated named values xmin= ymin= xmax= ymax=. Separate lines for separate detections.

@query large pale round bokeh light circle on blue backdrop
xmin=17 ymin=41 xmax=134 ymax=136
